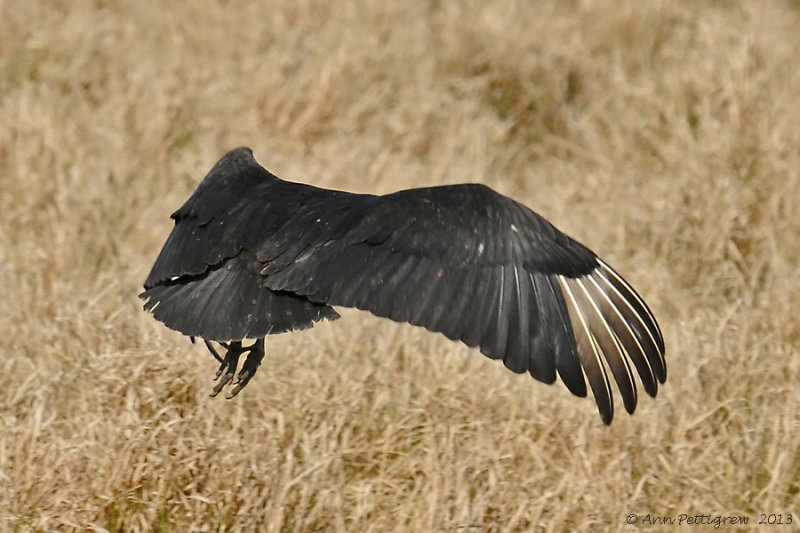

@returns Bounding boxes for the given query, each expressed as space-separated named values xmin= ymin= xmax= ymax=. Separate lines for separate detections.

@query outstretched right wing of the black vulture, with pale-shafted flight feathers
xmin=256 ymin=175 xmax=666 ymax=422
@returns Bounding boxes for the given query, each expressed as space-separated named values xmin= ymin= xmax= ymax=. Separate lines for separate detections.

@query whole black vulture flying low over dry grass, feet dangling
xmin=140 ymin=148 xmax=667 ymax=424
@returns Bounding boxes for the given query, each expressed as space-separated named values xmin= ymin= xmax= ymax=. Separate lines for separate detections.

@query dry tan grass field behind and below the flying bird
xmin=0 ymin=0 xmax=800 ymax=532
